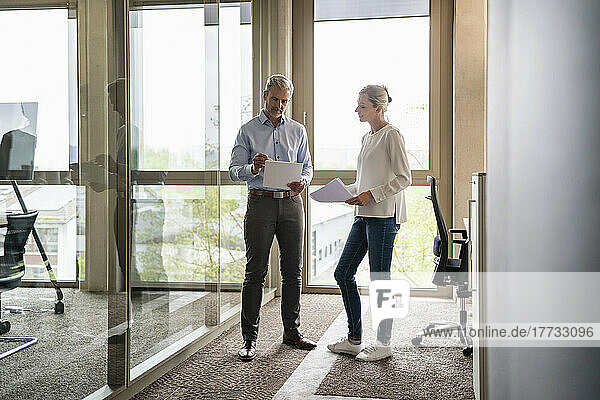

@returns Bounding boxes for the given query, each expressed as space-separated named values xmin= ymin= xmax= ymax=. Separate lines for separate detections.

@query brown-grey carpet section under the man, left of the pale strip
xmin=135 ymin=295 xmax=343 ymax=400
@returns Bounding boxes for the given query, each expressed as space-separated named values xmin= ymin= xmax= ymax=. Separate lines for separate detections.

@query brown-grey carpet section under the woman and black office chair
xmin=316 ymin=299 xmax=475 ymax=400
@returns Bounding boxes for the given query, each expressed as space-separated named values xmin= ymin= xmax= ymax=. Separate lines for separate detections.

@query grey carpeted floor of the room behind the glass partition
xmin=0 ymin=287 xmax=240 ymax=400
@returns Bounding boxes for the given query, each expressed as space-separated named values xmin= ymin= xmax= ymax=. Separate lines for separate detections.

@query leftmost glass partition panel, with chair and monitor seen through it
xmin=0 ymin=8 xmax=111 ymax=399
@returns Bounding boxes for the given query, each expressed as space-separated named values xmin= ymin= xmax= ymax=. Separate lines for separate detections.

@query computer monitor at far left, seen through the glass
xmin=0 ymin=102 xmax=38 ymax=180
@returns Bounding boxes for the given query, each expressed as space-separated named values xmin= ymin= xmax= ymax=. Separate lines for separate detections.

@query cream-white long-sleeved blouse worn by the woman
xmin=347 ymin=124 xmax=411 ymax=224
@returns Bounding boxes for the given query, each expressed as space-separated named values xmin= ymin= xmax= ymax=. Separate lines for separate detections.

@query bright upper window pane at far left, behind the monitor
xmin=0 ymin=9 xmax=78 ymax=172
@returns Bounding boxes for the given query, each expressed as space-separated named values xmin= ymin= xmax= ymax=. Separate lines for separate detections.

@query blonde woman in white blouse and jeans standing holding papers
xmin=327 ymin=85 xmax=411 ymax=361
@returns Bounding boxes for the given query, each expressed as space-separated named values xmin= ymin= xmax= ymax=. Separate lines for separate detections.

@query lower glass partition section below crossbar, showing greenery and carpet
xmin=131 ymin=185 xmax=221 ymax=367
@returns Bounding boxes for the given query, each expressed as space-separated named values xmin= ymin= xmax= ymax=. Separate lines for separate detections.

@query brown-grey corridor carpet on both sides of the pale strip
xmin=135 ymin=295 xmax=474 ymax=400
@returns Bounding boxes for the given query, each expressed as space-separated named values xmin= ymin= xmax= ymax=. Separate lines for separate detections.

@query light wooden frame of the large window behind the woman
xmin=291 ymin=0 xmax=454 ymax=297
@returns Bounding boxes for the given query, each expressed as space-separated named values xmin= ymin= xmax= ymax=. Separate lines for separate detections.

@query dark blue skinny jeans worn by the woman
xmin=333 ymin=217 xmax=400 ymax=344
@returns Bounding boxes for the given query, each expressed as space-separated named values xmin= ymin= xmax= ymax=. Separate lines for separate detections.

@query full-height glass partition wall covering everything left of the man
xmin=0 ymin=0 xmax=262 ymax=399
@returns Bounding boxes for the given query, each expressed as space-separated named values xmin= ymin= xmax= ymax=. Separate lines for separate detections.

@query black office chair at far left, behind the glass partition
xmin=0 ymin=211 xmax=38 ymax=360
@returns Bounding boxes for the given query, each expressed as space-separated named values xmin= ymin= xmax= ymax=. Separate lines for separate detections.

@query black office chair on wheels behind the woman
xmin=412 ymin=176 xmax=473 ymax=357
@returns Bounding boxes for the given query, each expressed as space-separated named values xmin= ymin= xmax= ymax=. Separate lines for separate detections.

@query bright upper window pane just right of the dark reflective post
xmin=129 ymin=6 xmax=209 ymax=170
